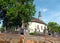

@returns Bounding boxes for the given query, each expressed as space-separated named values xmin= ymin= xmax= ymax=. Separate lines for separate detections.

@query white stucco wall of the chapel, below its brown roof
xmin=28 ymin=22 xmax=47 ymax=33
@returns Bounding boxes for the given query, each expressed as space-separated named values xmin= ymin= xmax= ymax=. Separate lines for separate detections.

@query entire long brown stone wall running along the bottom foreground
xmin=0 ymin=34 xmax=60 ymax=43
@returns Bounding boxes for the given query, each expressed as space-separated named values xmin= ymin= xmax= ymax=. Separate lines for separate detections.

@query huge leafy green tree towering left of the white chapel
xmin=0 ymin=0 xmax=35 ymax=31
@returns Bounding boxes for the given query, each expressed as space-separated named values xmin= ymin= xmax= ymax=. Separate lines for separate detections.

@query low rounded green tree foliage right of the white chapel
xmin=47 ymin=22 xmax=60 ymax=33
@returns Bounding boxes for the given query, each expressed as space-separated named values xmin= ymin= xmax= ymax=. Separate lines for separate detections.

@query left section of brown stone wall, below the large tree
xmin=0 ymin=34 xmax=24 ymax=43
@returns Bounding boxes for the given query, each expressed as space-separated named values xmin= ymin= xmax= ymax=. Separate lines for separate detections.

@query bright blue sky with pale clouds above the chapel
xmin=34 ymin=0 xmax=60 ymax=24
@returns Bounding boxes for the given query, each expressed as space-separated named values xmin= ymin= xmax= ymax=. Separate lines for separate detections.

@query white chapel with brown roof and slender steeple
xmin=28 ymin=12 xmax=47 ymax=33
